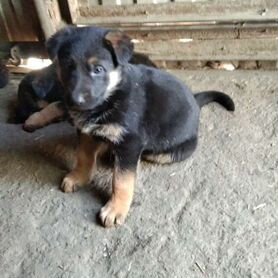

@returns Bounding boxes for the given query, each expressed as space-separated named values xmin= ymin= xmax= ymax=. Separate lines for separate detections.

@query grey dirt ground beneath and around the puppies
xmin=0 ymin=71 xmax=278 ymax=278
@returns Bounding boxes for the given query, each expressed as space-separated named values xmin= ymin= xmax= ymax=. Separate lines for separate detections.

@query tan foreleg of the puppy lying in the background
xmin=24 ymin=102 xmax=64 ymax=130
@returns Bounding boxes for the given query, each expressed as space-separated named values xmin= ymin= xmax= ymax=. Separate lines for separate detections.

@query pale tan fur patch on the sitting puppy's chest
xmin=82 ymin=124 xmax=125 ymax=143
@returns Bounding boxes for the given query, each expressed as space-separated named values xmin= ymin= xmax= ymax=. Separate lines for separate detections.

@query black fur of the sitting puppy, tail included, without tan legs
xmin=48 ymin=27 xmax=234 ymax=170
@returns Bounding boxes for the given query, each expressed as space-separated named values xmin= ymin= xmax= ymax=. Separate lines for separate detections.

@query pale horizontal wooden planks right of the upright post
xmin=68 ymin=0 xmax=278 ymax=66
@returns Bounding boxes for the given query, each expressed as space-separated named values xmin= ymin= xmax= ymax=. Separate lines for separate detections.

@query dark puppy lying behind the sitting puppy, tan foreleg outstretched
xmin=14 ymin=53 xmax=156 ymax=132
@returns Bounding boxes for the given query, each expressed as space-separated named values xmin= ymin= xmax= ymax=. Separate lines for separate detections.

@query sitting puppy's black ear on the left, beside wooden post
xmin=45 ymin=26 xmax=76 ymax=60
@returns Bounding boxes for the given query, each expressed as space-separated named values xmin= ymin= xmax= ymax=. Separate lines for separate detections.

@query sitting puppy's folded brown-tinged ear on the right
xmin=105 ymin=30 xmax=134 ymax=65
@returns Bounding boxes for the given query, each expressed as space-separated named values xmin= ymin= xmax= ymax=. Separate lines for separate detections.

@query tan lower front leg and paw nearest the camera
xmin=100 ymin=167 xmax=136 ymax=227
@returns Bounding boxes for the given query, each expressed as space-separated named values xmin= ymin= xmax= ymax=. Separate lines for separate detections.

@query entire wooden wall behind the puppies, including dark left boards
xmin=0 ymin=0 xmax=278 ymax=71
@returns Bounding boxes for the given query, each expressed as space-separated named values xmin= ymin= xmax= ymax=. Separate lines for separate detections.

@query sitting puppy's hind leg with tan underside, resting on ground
xmin=142 ymin=138 xmax=197 ymax=164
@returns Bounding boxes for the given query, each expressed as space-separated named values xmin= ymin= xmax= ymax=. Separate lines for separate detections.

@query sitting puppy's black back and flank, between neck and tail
xmin=125 ymin=65 xmax=200 ymax=148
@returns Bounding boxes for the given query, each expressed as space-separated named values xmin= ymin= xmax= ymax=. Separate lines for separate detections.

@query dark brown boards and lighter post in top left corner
xmin=0 ymin=0 xmax=64 ymax=43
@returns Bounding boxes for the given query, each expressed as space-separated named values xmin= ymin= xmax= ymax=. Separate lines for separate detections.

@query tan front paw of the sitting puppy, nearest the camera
xmin=99 ymin=200 xmax=129 ymax=228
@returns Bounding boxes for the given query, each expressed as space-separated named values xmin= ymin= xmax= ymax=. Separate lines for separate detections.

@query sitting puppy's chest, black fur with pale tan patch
xmin=70 ymin=109 xmax=126 ymax=144
